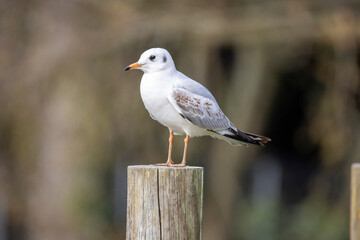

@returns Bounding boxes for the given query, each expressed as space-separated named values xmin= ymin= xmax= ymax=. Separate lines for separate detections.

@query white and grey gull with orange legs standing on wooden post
xmin=124 ymin=48 xmax=271 ymax=167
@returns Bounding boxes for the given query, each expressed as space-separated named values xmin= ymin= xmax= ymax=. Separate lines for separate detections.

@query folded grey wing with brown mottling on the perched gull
xmin=168 ymin=87 xmax=236 ymax=131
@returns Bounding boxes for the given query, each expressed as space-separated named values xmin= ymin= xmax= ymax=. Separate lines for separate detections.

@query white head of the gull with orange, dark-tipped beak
xmin=124 ymin=48 xmax=175 ymax=73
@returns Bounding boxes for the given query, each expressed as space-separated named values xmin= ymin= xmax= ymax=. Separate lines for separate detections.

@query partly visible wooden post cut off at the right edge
xmin=350 ymin=163 xmax=360 ymax=240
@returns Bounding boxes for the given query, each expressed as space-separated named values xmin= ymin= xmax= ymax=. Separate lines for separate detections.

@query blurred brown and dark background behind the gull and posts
xmin=0 ymin=0 xmax=360 ymax=240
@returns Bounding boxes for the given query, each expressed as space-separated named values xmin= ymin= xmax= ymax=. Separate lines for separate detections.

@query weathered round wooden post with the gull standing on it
xmin=126 ymin=165 xmax=203 ymax=240
